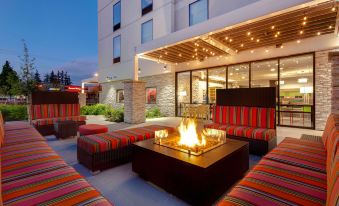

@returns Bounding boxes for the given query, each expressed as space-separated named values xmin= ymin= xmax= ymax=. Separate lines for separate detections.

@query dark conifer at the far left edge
xmin=0 ymin=61 xmax=21 ymax=97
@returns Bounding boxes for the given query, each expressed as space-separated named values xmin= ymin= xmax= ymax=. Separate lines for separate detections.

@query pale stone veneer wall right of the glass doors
xmin=315 ymin=49 xmax=339 ymax=130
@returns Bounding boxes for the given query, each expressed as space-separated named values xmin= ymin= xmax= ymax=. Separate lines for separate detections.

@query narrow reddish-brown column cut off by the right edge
xmin=329 ymin=51 xmax=339 ymax=113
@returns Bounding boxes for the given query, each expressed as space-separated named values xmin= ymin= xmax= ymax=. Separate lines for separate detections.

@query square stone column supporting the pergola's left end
xmin=124 ymin=80 xmax=146 ymax=124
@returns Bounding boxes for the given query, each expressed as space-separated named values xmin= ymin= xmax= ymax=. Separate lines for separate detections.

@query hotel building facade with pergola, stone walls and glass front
xmin=98 ymin=0 xmax=339 ymax=130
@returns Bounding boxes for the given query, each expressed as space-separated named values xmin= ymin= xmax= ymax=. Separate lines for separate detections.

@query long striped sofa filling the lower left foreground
xmin=0 ymin=113 xmax=112 ymax=206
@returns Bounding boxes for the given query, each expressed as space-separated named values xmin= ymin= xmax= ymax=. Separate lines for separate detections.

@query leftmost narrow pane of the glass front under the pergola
xmin=177 ymin=72 xmax=191 ymax=116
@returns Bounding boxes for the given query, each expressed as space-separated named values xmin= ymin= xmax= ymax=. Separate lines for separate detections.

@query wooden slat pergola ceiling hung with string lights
xmin=144 ymin=1 xmax=338 ymax=63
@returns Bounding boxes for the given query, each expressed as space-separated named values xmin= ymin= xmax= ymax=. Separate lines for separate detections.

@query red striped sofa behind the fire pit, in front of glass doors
xmin=205 ymin=105 xmax=277 ymax=155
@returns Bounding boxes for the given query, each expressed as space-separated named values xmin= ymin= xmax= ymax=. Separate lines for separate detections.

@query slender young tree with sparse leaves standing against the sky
xmin=19 ymin=40 xmax=35 ymax=96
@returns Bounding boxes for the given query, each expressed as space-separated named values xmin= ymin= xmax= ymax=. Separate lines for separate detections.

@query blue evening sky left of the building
xmin=0 ymin=0 xmax=98 ymax=85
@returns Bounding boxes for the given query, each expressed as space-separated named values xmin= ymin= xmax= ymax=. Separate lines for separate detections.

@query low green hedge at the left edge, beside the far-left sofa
xmin=0 ymin=104 xmax=28 ymax=121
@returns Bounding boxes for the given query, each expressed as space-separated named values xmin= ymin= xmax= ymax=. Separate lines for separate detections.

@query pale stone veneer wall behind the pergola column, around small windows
xmin=99 ymin=73 xmax=175 ymax=116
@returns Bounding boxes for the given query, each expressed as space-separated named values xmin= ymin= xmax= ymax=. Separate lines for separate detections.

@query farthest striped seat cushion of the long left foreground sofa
xmin=4 ymin=128 xmax=46 ymax=146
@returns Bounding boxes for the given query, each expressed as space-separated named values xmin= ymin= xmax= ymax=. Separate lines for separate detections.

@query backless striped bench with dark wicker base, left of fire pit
xmin=77 ymin=125 xmax=175 ymax=172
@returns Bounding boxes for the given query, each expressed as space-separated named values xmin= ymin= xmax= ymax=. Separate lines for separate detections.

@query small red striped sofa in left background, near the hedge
xmin=29 ymin=104 xmax=86 ymax=136
